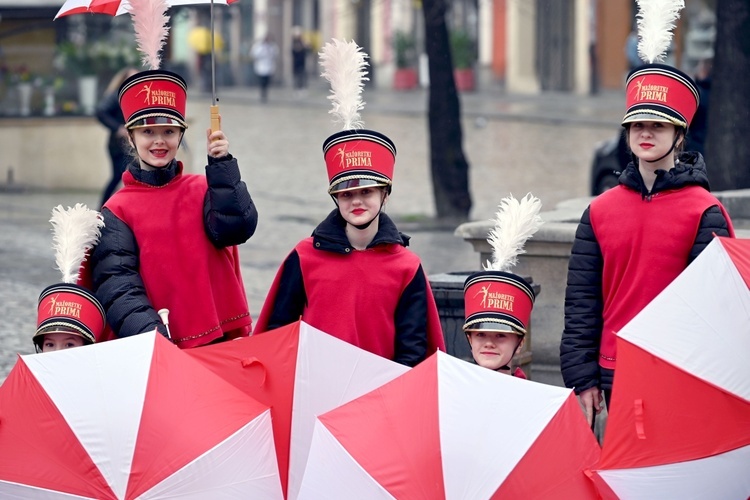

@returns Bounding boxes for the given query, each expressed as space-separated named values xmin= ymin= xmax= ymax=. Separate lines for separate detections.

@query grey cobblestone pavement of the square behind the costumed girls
xmin=0 ymin=87 xmax=622 ymax=380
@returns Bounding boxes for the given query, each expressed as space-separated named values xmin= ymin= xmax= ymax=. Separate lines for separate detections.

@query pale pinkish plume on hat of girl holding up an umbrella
xmin=128 ymin=0 xmax=169 ymax=69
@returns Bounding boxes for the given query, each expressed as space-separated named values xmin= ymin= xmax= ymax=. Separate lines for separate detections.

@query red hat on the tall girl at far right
xmin=622 ymin=63 xmax=699 ymax=129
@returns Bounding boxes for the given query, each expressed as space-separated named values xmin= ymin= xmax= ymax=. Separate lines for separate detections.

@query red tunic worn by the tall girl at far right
xmin=590 ymin=186 xmax=734 ymax=369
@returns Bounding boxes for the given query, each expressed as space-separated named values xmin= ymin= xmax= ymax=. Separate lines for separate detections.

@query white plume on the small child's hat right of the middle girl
xmin=484 ymin=193 xmax=544 ymax=272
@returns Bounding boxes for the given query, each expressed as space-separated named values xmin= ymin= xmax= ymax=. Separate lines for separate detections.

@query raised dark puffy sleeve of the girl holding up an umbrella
xmin=203 ymin=155 xmax=258 ymax=248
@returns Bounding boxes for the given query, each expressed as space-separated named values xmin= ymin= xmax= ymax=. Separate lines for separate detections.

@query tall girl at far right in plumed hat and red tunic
xmin=560 ymin=1 xmax=734 ymax=423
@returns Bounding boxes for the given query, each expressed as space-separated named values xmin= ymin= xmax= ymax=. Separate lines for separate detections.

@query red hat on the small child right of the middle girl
xmin=463 ymin=271 xmax=536 ymax=335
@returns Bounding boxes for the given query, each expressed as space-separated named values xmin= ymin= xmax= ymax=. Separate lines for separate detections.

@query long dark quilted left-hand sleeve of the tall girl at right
xmin=560 ymin=207 xmax=603 ymax=394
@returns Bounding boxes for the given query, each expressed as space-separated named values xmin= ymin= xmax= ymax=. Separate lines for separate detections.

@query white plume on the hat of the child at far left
xmin=49 ymin=203 xmax=104 ymax=283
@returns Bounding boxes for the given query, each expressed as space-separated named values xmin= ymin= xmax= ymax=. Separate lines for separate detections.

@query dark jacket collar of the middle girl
xmin=312 ymin=208 xmax=410 ymax=254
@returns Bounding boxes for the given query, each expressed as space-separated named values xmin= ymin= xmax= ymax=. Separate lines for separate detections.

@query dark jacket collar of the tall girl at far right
xmin=619 ymin=151 xmax=711 ymax=198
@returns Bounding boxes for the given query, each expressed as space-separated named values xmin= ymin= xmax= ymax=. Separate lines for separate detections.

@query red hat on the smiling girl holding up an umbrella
xmin=119 ymin=69 xmax=187 ymax=129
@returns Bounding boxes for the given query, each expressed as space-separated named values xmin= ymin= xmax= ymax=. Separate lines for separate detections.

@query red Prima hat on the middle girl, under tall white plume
xmin=323 ymin=129 xmax=396 ymax=194
